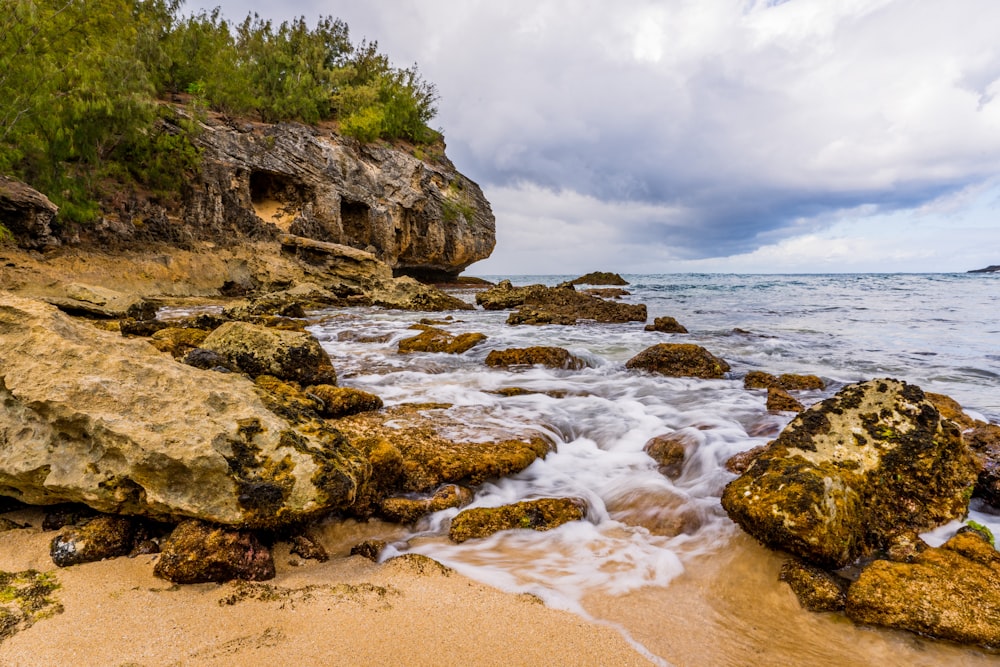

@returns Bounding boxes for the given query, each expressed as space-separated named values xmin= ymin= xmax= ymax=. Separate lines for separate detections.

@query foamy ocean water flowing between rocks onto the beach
xmin=311 ymin=274 xmax=1000 ymax=665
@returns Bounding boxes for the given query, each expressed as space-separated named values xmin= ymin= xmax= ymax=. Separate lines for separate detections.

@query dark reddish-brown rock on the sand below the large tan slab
xmin=153 ymin=520 xmax=274 ymax=584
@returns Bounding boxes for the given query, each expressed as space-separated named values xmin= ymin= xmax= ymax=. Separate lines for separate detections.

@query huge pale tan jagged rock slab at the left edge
xmin=0 ymin=293 xmax=369 ymax=527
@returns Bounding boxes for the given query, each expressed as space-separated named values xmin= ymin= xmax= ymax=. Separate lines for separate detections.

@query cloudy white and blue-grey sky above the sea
xmin=195 ymin=0 xmax=1000 ymax=274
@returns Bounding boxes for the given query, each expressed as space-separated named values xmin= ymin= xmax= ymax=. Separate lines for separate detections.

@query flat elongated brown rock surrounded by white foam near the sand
xmin=448 ymin=498 xmax=586 ymax=542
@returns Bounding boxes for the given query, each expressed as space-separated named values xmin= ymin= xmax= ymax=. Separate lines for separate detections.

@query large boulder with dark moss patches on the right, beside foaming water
xmin=722 ymin=379 xmax=976 ymax=568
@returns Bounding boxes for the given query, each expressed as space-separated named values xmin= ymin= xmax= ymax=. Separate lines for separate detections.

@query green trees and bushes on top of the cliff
xmin=0 ymin=0 xmax=439 ymax=232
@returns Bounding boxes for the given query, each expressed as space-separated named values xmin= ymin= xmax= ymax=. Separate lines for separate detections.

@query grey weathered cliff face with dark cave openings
xmin=183 ymin=113 xmax=496 ymax=279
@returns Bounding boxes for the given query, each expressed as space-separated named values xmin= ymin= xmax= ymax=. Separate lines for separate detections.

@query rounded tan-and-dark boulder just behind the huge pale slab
xmin=200 ymin=322 xmax=337 ymax=385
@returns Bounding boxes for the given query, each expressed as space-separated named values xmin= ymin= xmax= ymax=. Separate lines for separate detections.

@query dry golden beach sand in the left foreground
xmin=0 ymin=512 xmax=651 ymax=667
